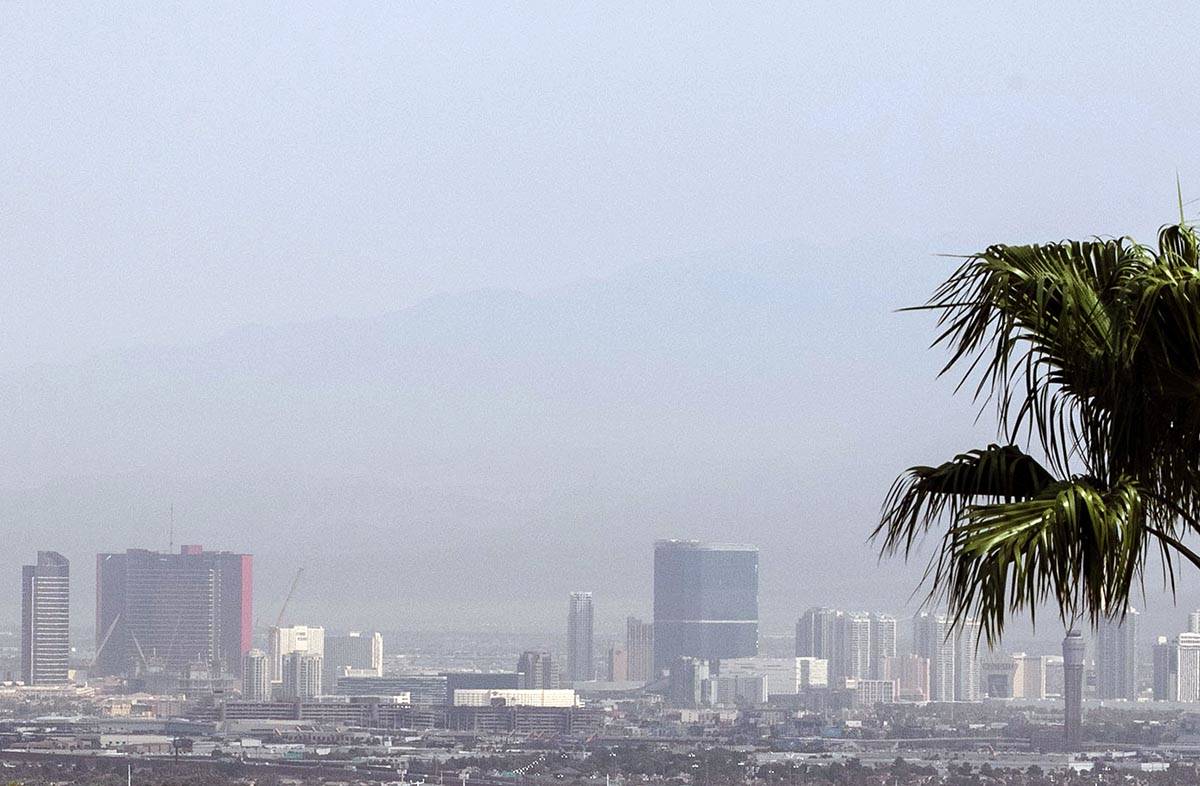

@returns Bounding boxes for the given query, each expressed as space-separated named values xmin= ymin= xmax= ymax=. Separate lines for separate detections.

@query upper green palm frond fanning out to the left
xmin=924 ymin=239 xmax=1153 ymax=474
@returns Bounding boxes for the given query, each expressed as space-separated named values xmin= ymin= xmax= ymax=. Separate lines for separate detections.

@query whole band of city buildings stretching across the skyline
xmin=20 ymin=540 xmax=1200 ymax=758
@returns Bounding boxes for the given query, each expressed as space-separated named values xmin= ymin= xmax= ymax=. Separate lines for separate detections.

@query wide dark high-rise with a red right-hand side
xmin=96 ymin=546 xmax=253 ymax=674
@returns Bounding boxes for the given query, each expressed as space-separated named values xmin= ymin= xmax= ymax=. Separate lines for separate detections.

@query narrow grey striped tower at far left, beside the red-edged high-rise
xmin=20 ymin=551 xmax=71 ymax=685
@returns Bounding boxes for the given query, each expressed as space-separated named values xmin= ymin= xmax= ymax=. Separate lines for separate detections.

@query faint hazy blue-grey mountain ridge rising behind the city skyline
xmin=0 ymin=246 xmax=979 ymax=625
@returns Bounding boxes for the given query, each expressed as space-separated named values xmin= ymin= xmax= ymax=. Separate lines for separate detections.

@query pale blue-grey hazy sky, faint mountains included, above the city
xmin=0 ymin=4 xmax=1200 ymax=641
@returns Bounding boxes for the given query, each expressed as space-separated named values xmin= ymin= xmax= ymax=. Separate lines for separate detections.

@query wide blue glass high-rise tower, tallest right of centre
xmin=654 ymin=540 xmax=758 ymax=671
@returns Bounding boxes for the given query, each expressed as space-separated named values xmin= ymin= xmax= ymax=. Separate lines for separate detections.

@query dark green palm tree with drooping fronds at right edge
xmin=872 ymin=218 xmax=1200 ymax=643
